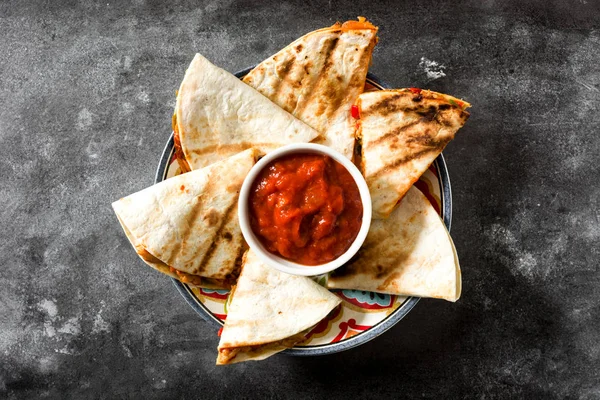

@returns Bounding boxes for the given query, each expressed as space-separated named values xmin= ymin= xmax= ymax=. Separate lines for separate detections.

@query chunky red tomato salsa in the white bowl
xmin=249 ymin=153 xmax=363 ymax=265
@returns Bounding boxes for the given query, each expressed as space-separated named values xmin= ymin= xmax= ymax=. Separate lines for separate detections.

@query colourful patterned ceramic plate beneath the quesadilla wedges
xmin=155 ymin=68 xmax=452 ymax=356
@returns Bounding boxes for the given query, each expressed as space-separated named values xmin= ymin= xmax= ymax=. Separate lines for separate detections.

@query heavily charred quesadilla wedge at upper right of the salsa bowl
xmin=357 ymin=89 xmax=470 ymax=218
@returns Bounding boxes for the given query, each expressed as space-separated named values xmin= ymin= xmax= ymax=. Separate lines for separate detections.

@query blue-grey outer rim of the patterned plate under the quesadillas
xmin=154 ymin=67 xmax=452 ymax=356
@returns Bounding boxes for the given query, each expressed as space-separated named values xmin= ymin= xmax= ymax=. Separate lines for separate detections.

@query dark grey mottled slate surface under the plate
xmin=0 ymin=0 xmax=600 ymax=399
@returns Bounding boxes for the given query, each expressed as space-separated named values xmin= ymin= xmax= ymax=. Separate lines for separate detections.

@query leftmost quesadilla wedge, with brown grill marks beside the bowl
xmin=112 ymin=149 xmax=258 ymax=287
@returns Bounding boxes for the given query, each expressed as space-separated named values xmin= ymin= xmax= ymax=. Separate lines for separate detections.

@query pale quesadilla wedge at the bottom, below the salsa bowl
xmin=217 ymin=250 xmax=341 ymax=365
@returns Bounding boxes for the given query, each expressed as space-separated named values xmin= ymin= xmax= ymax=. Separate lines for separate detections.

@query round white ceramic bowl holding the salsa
xmin=238 ymin=143 xmax=372 ymax=276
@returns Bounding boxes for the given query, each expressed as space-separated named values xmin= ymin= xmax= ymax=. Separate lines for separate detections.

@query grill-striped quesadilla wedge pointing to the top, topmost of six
xmin=244 ymin=17 xmax=377 ymax=159
